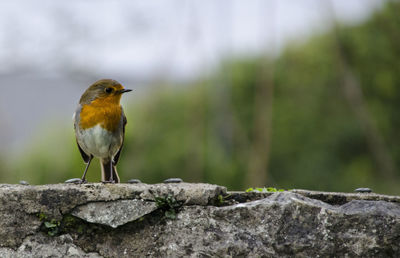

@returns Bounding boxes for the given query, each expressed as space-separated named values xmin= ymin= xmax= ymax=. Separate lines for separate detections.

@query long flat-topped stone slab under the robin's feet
xmin=0 ymin=183 xmax=226 ymax=247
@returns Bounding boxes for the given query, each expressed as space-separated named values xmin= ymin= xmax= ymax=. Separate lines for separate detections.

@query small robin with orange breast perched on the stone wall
xmin=72 ymin=79 xmax=132 ymax=183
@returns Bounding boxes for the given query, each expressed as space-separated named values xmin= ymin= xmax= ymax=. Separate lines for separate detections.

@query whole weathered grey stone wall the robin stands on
xmin=0 ymin=183 xmax=400 ymax=257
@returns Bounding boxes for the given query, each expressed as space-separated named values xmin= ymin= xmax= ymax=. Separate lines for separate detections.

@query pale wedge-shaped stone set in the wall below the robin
xmin=71 ymin=200 xmax=157 ymax=228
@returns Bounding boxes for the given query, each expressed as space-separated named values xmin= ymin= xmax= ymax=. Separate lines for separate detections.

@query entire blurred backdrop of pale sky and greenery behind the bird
xmin=0 ymin=0 xmax=400 ymax=194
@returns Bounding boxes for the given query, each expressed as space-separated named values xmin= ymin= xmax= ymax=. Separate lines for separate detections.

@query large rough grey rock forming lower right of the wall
xmin=80 ymin=192 xmax=400 ymax=257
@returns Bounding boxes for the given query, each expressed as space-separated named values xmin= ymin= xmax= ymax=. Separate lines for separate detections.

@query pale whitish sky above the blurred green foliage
xmin=0 ymin=0 xmax=382 ymax=77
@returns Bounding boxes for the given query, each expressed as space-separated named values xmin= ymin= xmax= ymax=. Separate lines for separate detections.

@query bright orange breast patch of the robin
xmin=80 ymin=97 xmax=122 ymax=132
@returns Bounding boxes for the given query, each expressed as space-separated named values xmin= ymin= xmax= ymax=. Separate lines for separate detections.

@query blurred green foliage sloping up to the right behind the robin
xmin=0 ymin=2 xmax=400 ymax=194
